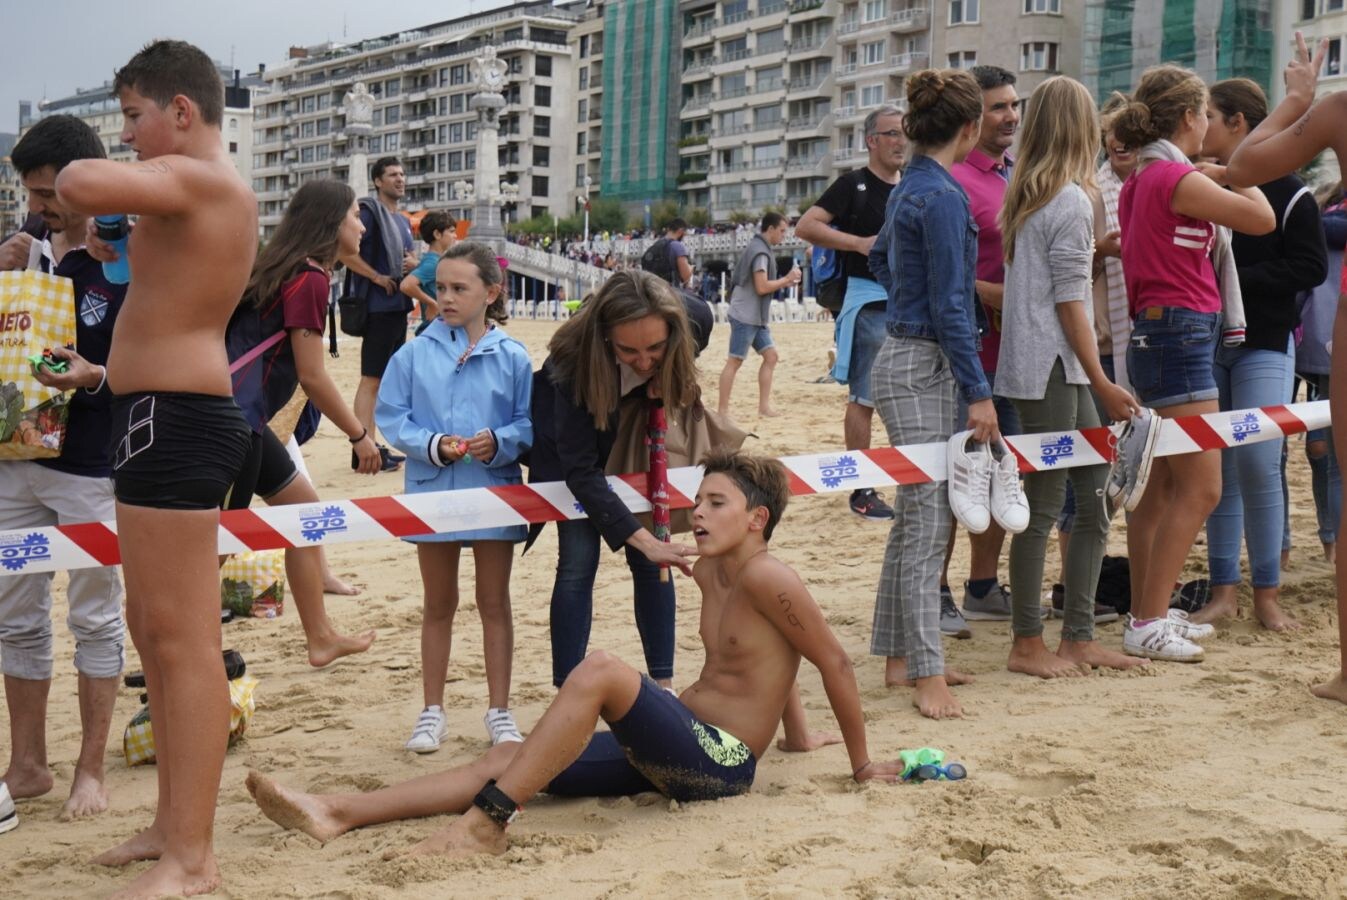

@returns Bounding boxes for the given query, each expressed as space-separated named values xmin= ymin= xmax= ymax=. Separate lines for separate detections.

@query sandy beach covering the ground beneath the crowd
xmin=0 ymin=321 xmax=1347 ymax=900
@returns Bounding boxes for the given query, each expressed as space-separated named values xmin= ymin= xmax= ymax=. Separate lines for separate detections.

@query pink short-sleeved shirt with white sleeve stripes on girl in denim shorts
xmin=1118 ymin=160 xmax=1220 ymax=315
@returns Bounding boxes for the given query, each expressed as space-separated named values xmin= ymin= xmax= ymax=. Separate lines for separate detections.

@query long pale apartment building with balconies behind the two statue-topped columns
xmin=253 ymin=1 xmax=579 ymax=233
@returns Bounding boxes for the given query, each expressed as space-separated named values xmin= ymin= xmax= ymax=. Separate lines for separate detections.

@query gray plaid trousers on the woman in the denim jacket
xmin=870 ymin=335 xmax=956 ymax=678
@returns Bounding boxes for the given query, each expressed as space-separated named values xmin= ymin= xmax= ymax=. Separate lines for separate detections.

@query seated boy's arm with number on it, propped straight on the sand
xmin=742 ymin=560 xmax=902 ymax=781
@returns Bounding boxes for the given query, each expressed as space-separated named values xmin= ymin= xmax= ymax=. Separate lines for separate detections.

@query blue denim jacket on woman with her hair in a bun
xmin=869 ymin=156 xmax=991 ymax=403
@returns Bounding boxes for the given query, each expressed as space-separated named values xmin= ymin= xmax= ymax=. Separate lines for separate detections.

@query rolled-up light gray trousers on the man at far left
xmin=0 ymin=461 xmax=127 ymax=682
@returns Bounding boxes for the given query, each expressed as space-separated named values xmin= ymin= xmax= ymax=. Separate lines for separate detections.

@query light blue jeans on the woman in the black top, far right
xmin=1207 ymin=342 xmax=1296 ymax=587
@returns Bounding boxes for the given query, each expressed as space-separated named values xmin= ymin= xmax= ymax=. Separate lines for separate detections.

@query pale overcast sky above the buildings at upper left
xmin=0 ymin=0 xmax=508 ymax=132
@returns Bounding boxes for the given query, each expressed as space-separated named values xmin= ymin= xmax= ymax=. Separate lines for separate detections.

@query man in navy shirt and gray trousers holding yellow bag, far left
xmin=0 ymin=116 xmax=127 ymax=818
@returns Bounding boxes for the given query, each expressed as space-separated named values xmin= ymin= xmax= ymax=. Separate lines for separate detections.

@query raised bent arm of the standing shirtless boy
xmin=57 ymin=156 xmax=207 ymax=217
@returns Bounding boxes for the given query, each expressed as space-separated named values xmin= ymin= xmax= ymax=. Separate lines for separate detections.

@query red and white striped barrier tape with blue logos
xmin=0 ymin=400 xmax=1328 ymax=577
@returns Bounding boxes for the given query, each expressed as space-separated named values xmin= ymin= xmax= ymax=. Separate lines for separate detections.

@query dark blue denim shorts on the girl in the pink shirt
xmin=1127 ymin=306 xmax=1220 ymax=410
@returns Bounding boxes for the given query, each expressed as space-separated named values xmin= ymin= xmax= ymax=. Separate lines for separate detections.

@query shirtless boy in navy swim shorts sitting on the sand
xmin=248 ymin=453 xmax=902 ymax=856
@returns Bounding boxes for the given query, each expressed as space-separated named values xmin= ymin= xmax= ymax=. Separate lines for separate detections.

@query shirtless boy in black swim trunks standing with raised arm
xmin=57 ymin=40 xmax=257 ymax=897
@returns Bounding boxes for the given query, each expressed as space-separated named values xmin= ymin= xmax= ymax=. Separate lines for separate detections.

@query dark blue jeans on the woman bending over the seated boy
xmin=551 ymin=519 xmax=675 ymax=687
